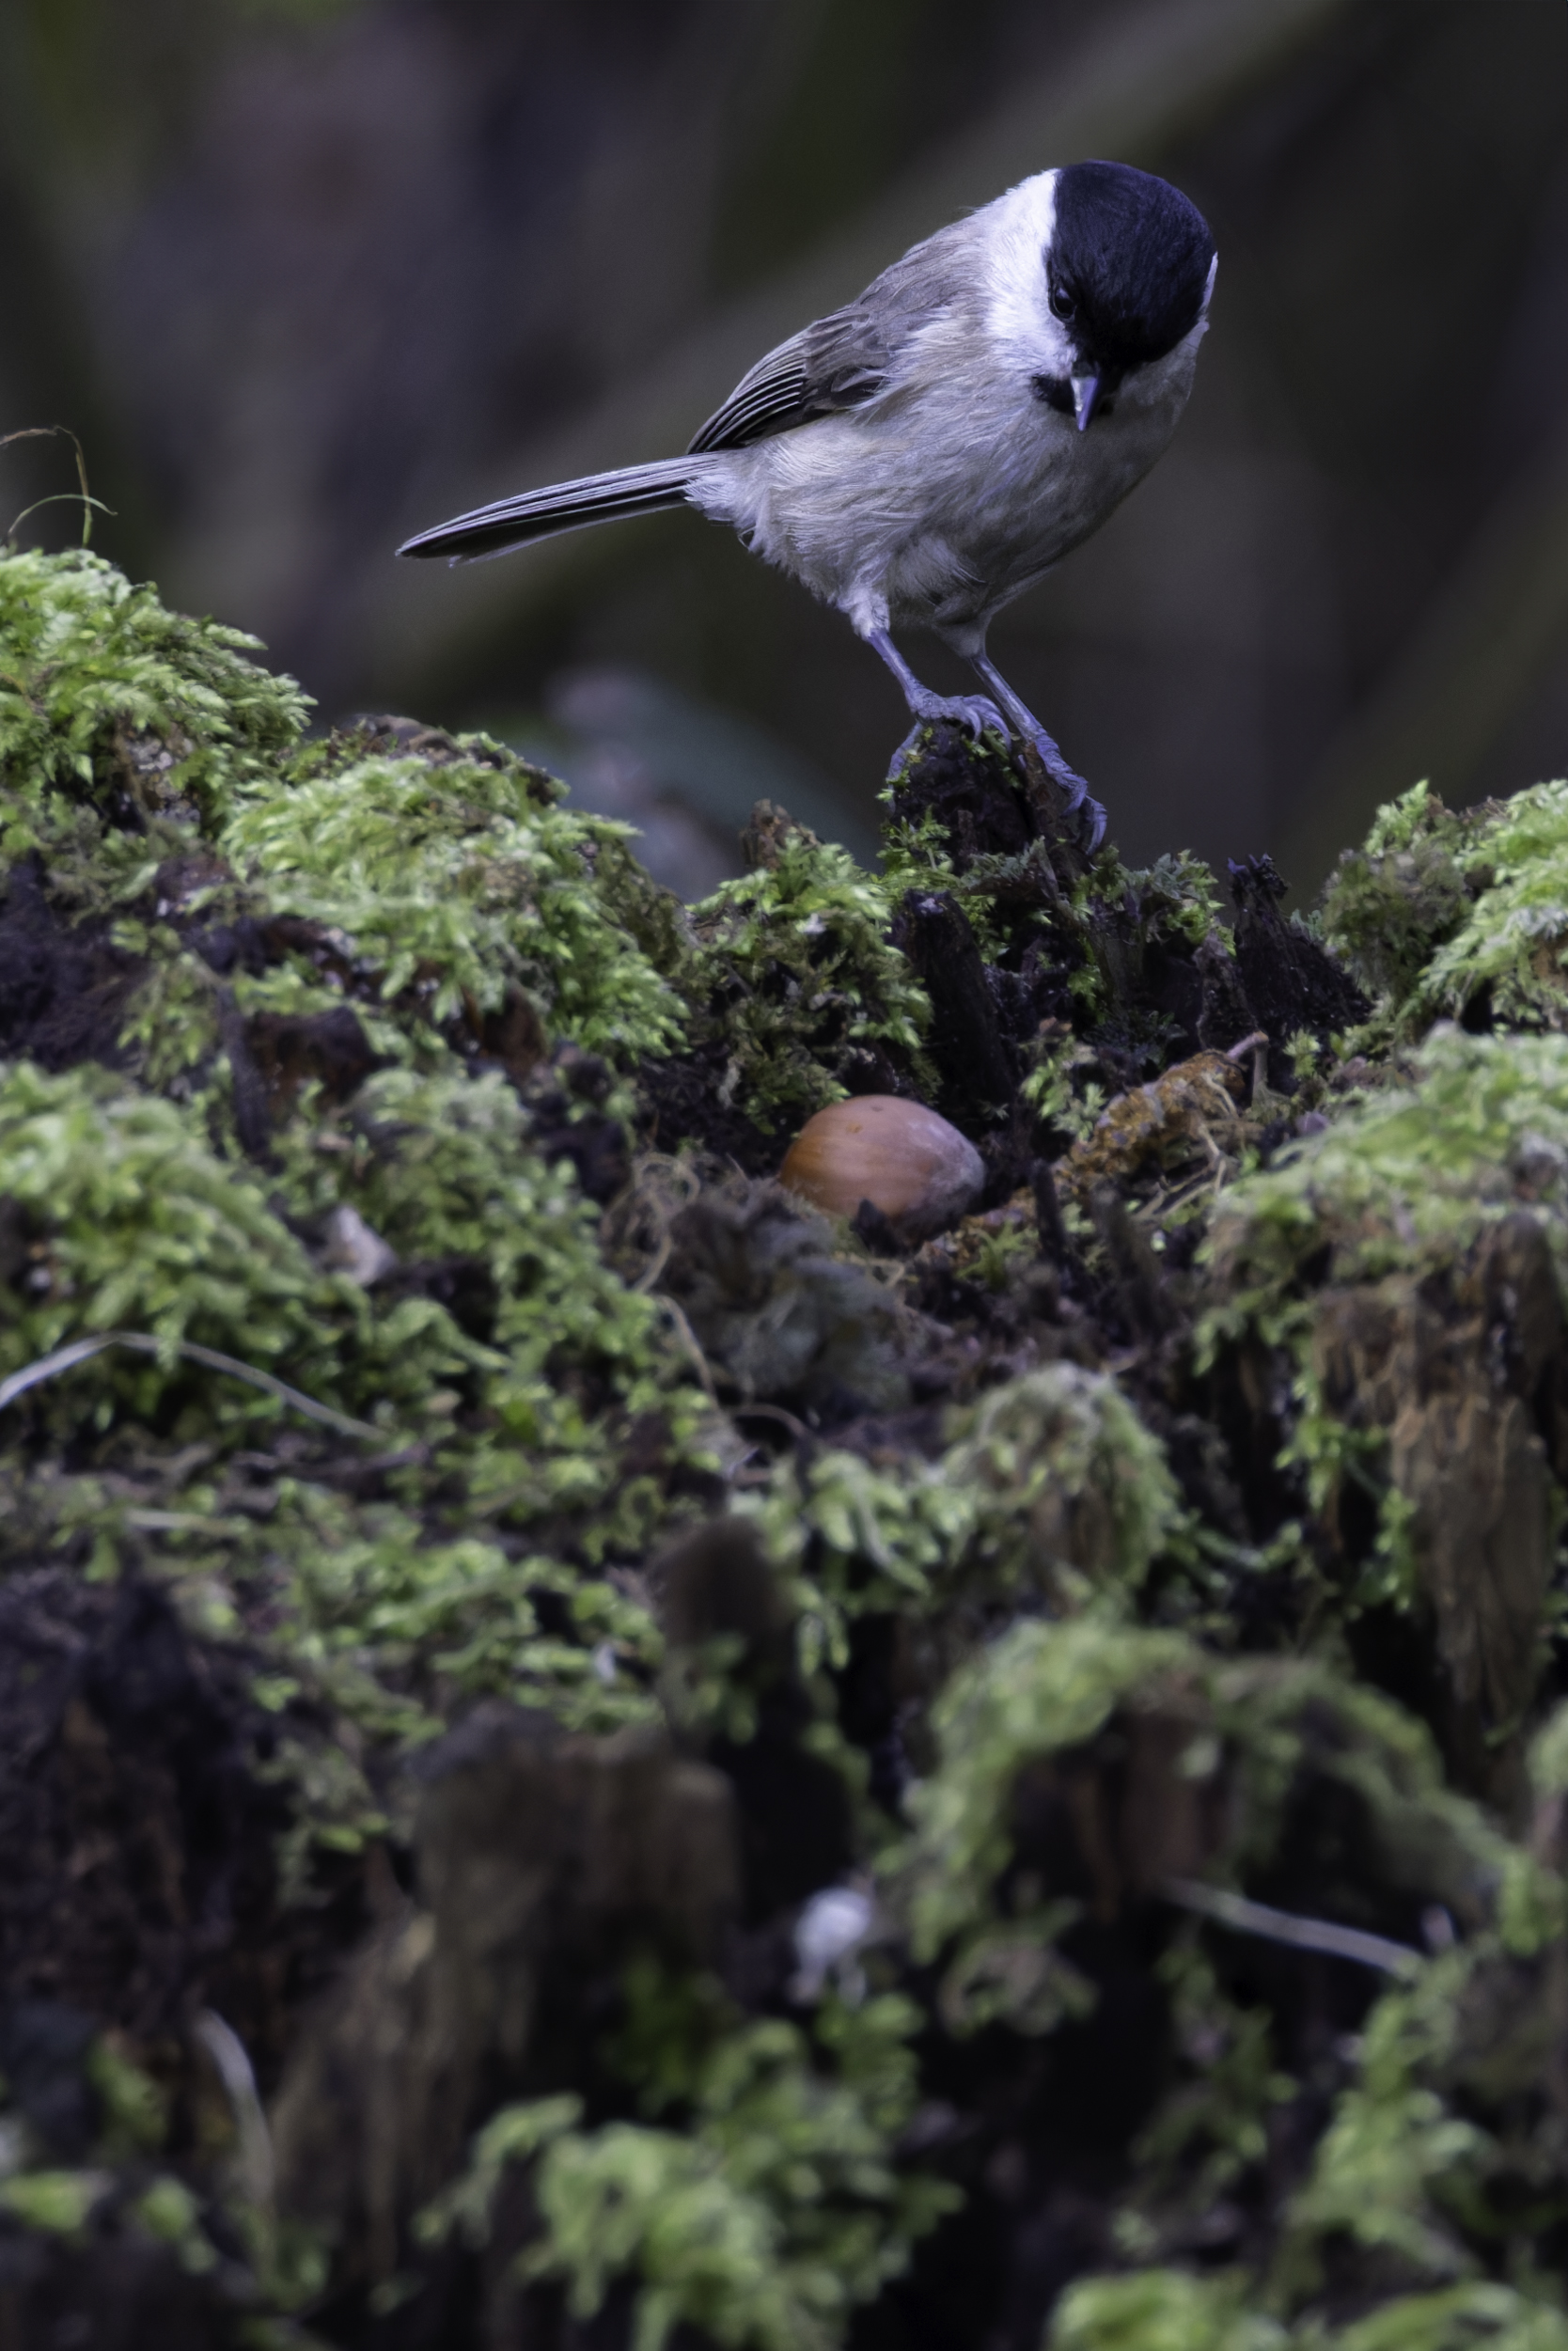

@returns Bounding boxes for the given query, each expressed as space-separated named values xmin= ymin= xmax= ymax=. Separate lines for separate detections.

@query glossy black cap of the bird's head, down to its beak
xmin=1043 ymin=163 xmax=1215 ymax=432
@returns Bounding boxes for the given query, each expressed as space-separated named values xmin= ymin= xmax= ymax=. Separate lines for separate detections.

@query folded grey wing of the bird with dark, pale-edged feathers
xmin=686 ymin=221 xmax=968 ymax=456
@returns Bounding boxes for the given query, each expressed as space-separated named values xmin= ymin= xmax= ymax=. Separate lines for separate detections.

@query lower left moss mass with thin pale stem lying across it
xmin=0 ymin=1065 xmax=708 ymax=1833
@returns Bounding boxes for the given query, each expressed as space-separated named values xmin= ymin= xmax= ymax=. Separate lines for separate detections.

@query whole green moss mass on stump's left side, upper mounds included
xmin=0 ymin=553 xmax=724 ymax=1842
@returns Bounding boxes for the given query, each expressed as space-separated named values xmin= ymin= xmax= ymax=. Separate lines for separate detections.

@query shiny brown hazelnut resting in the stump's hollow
xmin=778 ymin=1093 xmax=985 ymax=1242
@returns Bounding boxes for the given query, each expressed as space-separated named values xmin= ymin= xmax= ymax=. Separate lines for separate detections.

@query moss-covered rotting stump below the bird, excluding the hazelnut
xmin=0 ymin=553 xmax=1568 ymax=2351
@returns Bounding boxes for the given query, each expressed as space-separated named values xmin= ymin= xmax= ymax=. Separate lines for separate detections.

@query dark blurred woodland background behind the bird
xmin=0 ymin=0 xmax=1568 ymax=896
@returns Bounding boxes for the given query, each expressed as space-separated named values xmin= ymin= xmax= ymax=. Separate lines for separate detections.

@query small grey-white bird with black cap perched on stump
xmin=398 ymin=160 xmax=1217 ymax=849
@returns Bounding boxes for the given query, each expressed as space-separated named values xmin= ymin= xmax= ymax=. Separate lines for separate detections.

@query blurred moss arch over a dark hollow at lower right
xmin=891 ymin=1618 xmax=1563 ymax=2322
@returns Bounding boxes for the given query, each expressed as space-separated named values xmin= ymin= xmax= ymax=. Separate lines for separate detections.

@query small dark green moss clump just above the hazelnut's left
xmin=682 ymin=825 xmax=931 ymax=1133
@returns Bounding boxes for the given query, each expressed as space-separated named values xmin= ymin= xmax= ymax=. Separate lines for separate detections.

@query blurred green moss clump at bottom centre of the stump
xmin=423 ymin=1970 xmax=957 ymax=2351
